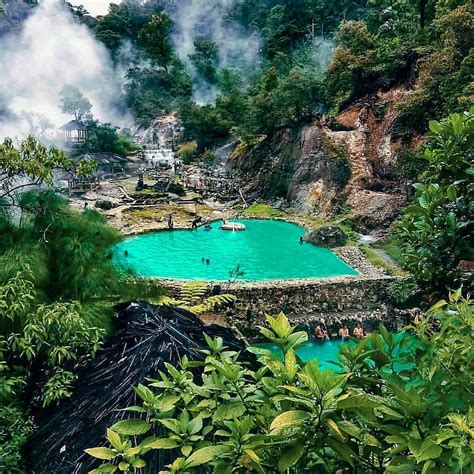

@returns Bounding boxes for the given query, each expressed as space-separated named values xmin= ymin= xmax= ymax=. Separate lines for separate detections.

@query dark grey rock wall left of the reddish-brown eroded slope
xmin=231 ymin=121 xmax=350 ymax=215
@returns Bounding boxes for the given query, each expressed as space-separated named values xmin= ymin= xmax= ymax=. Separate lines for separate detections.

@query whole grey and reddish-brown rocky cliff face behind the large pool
xmin=232 ymin=87 xmax=409 ymax=229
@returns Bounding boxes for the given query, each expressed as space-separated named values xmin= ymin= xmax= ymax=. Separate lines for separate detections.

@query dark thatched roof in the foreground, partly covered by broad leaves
xmin=27 ymin=302 xmax=248 ymax=474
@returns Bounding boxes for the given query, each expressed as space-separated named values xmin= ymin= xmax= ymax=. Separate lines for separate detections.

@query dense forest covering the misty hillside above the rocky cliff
xmin=83 ymin=0 xmax=473 ymax=152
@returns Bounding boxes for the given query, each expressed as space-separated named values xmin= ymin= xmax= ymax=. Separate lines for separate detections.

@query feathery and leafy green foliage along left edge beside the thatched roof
xmin=0 ymin=137 xmax=159 ymax=472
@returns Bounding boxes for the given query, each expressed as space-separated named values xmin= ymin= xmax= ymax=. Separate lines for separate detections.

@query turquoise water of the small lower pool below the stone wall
xmin=253 ymin=340 xmax=351 ymax=371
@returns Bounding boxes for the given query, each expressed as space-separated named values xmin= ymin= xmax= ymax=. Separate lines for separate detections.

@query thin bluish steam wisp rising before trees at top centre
xmin=167 ymin=0 xmax=261 ymax=103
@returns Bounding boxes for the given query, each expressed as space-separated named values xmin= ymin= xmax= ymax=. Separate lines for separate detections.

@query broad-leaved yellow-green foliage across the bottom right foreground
xmin=87 ymin=291 xmax=474 ymax=473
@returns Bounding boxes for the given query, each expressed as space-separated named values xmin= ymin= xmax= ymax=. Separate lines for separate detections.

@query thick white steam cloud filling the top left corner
xmin=0 ymin=0 xmax=125 ymax=138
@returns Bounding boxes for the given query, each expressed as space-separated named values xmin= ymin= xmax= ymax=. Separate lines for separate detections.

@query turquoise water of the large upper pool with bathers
xmin=115 ymin=219 xmax=357 ymax=281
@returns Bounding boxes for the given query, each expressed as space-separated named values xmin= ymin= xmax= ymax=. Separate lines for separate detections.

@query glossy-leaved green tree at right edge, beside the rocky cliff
xmin=395 ymin=110 xmax=474 ymax=292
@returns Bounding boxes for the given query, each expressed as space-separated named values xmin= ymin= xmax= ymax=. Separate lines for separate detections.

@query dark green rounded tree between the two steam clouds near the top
xmin=138 ymin=13 xmax=173 ymax=71
